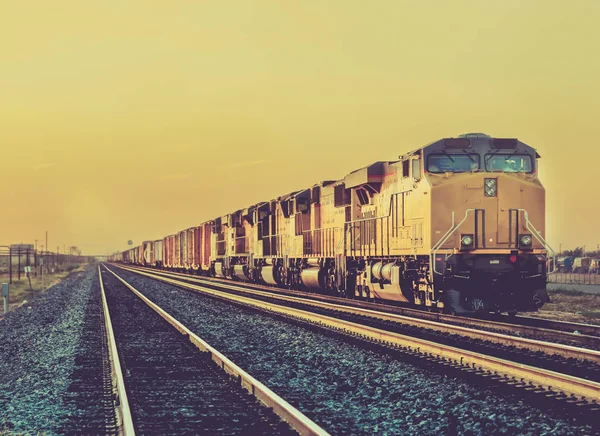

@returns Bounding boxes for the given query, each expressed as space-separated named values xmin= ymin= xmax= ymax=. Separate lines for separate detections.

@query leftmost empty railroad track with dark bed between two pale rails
xmin=98 ymin=267 xmax=327 ymax=435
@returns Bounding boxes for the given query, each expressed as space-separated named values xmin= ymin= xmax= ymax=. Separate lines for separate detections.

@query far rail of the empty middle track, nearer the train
xmin=116 ymin=268 xmax=600 ymax=364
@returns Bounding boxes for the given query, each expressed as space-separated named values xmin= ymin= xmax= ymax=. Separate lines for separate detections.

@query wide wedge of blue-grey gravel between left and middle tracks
xmin=113 ymin=268 xmax=593 ymax=435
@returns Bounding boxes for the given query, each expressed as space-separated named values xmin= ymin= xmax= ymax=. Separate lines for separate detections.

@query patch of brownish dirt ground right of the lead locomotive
xmin=527 ymin=290 xmax=600 ymax=325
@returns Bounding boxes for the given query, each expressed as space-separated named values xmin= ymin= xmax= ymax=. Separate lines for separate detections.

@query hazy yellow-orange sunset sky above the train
xmin=0 ymin=0 xmax=600 ymax=254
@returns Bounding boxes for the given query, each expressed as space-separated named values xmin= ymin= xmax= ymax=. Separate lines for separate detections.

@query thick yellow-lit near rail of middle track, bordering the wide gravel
xmin=106 ymin=271 xmax=600 ymax=403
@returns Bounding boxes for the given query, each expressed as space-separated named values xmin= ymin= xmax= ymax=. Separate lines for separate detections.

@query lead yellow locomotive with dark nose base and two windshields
xmin=346 ymin=134 xmax=554 ymax=313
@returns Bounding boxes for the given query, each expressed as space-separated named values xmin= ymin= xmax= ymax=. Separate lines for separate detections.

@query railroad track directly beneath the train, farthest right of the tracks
xmin=121 ymin=265 xmax=600 ymax=350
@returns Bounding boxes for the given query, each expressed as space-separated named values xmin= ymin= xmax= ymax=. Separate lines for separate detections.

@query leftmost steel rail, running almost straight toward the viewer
xmin=98 ymin=265 xmax=135 ymax=436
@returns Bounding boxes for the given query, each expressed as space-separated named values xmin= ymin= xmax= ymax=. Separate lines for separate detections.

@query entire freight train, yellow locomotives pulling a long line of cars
xmin=110 ymin=133 xmax=555 ymax=313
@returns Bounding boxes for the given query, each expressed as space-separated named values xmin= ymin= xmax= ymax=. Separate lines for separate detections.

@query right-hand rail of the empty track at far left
xmin=104 ymin=265 xmax=329 ymax=436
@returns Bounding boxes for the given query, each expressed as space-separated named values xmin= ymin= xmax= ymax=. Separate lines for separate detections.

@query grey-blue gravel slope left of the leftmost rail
xmin=0 ymin=267 xmax=97 ymax=434
